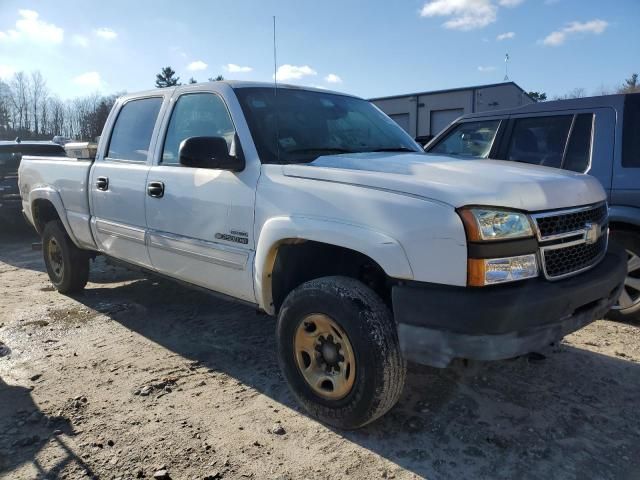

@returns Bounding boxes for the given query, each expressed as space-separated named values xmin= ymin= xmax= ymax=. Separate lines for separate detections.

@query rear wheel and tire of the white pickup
xmin=42 ymin=220 xmax=89 ymax=293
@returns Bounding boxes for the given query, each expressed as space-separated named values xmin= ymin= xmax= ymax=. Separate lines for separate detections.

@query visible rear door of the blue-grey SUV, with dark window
xmin=497 ymin=108 xmax=615 ymax=195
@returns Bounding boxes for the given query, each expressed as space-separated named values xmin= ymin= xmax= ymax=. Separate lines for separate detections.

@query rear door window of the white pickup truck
xmin=107 ymin=97 xmax=162 ymax=162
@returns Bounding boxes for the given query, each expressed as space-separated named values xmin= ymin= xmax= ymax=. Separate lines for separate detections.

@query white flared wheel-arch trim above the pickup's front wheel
xmin=254 ymin=216 xmax=413 ymax=314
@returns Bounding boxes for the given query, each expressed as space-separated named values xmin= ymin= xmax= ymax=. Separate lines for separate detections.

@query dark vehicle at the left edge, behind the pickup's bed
xmin=0 ymin=140 xmax=65 ymax=225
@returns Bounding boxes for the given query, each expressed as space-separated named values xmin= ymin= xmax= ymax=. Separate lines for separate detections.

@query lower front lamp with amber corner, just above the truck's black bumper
xmin=467 ymin=254 xmax=538 ymax=287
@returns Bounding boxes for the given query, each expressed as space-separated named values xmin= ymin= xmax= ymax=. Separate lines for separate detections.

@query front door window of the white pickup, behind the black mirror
xmin=162 ymin=93 xmax=235 ymax=165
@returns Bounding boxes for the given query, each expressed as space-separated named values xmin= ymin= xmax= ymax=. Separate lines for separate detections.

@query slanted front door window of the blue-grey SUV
xmin=429 ymin=120 xmax=500 ymax=158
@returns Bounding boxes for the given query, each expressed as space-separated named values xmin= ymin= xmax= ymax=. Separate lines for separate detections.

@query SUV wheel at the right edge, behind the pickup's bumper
xmin=607 ymin=230 xmax=640 ymax=322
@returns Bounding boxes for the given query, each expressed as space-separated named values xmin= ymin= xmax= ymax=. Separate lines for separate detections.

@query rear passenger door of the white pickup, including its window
xmin=89 ymin=95 xmax=164 ymax=267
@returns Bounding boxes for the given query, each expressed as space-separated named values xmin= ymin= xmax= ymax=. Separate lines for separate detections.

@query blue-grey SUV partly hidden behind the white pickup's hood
xmin=425 ymin=93 xmax=640 ymax=320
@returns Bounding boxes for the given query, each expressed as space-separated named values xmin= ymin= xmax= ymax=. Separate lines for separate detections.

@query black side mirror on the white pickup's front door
xmin=178 ymin=135 xmax=245 ymax=172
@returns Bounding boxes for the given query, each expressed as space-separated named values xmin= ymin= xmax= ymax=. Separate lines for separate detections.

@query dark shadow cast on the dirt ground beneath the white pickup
xmin=53 ymin=266 xmax=640 ymax=479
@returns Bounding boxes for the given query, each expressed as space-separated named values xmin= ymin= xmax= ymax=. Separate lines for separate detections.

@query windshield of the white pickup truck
xmin=235 ymin=87 xmax=422 ymax=163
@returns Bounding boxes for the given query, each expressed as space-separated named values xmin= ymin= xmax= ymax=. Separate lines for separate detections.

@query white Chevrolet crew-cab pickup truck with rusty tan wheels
xmin=19 ymin=82 xmax=626 ymax=428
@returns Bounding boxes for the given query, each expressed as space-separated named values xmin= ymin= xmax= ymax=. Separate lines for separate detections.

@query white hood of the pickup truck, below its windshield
xmin=283 ymin=152 xmax=606 ymax=212
